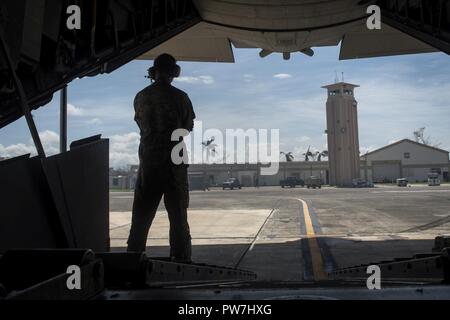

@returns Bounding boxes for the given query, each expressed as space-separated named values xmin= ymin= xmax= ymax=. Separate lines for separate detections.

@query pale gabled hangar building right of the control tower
xmin=361 ymin=139 xmax=449 ymax=182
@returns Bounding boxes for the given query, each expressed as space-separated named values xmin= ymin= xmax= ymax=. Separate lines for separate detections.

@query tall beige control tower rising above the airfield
xmin=322 ymin=82 xmax=360 ymax=187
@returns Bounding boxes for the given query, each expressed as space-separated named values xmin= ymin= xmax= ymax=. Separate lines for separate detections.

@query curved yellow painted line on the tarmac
xmin=297 ymin=199 xmax=327 ymax=281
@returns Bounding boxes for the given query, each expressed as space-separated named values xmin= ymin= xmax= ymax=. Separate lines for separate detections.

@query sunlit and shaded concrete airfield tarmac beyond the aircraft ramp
xmin=110 ymin=185 xmax=450 ymax=281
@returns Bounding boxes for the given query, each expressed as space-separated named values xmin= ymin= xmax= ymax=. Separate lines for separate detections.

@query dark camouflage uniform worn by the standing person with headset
xmin=128 ymin=82 xmax=195 ymax=260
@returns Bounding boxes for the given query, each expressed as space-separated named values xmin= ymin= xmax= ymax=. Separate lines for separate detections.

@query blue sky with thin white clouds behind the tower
xmin=0 ymin=47 xmax=450 ymax=167
